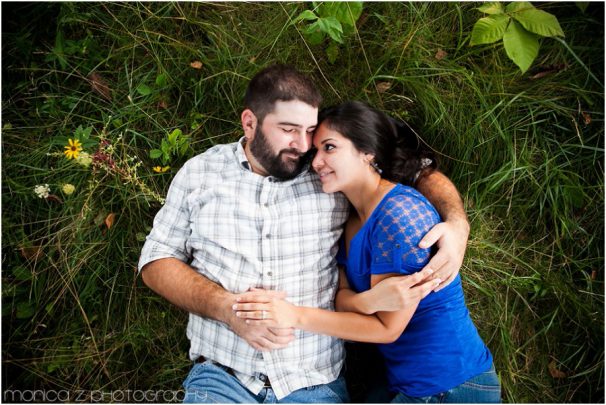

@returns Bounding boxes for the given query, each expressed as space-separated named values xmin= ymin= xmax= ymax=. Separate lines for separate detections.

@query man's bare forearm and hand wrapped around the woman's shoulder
xmin=416 ymin=171 xmax=469 ymax=291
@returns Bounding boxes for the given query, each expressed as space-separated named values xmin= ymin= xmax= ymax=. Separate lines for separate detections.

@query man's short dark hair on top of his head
xmin=244 ymin=64 xmax=322 ymax=123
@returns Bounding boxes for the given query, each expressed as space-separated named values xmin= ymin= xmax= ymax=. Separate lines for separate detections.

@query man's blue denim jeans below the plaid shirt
xmin=183 ymin=361 xmax=349 ymax=404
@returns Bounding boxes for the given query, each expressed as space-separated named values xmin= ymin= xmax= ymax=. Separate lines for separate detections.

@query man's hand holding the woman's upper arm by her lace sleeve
xmin=419 ymin=221 xmax=469 ymax=291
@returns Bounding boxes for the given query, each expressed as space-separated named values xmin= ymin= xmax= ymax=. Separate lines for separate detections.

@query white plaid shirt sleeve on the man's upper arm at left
xmin=138 ymin=163 xmax=191 ymax=272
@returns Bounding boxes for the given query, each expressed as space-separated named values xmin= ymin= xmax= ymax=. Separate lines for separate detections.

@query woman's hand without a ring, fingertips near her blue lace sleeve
xmin=362 ymin=269 xmax=441 ymax=314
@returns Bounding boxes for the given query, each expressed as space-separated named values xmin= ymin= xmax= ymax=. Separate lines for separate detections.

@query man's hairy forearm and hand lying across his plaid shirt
xmin=141 ymin=258 xmax=294 ymax=350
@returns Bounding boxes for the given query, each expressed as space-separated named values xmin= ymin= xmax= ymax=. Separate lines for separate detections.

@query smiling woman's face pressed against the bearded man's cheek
xmin=311 ymin=124 xmax=372 ymax=193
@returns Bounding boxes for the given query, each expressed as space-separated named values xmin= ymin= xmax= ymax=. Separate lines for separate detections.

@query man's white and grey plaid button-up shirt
xmin=139 ymin=140 xmax=349 ymax=399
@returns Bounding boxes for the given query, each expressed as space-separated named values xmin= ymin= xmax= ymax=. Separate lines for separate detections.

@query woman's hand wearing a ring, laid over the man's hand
xmin=232 ymin=289 xmax=299 ymax=328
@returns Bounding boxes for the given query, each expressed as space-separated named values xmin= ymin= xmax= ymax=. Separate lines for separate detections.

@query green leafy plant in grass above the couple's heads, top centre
xmin=293 ymin=1 xmax=363 ymax=63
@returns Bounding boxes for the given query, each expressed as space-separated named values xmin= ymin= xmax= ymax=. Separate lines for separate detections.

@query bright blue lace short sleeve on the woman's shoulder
xmin=370 ymin=195 xmax=440 ymax=274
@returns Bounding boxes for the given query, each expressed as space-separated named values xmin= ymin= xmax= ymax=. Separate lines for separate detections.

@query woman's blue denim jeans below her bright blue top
xmin=391 ymin=366 xmax=501 ymax=404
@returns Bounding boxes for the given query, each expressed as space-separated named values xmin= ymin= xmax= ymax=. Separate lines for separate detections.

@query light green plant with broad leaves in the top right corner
xmin=470 ymin=1 xmax=564 ymax=73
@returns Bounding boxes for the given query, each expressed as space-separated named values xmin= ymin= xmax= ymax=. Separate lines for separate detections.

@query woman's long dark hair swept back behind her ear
xmin=318 ymin=101 xmax=437 ymax=186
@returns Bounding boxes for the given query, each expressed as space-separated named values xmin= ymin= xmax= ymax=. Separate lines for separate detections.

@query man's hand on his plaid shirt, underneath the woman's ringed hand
xmin=228 ymin=289 xmax=295 ymax=351
